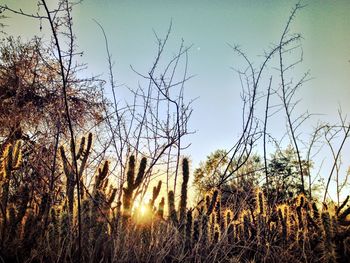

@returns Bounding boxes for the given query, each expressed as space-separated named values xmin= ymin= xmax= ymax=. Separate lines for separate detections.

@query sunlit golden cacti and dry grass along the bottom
xmin=1 ymin=147 xmax=350 ymax=262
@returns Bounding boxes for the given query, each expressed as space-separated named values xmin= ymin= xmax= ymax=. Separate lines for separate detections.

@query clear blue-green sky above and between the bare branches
xmin=0 ymin=0 xmax=350 ymax=200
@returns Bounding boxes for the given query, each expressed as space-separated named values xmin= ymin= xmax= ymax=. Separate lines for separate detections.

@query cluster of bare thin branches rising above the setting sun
xmin=96 ymin=22 xmax=192 ymax=206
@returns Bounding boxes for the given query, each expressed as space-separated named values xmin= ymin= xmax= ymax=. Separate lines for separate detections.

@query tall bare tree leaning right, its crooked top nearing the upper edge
xmin=213 ymin=4 xmax=302 ymax=194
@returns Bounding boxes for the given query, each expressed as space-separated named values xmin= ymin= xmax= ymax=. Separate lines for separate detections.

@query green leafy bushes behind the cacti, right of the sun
xmin=194 ymin=146 xmax=311 ymax=207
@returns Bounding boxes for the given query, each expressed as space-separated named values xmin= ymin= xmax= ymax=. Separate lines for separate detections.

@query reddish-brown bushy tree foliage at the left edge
xmin=0 ymin=37 xmax=101 ymax=139
